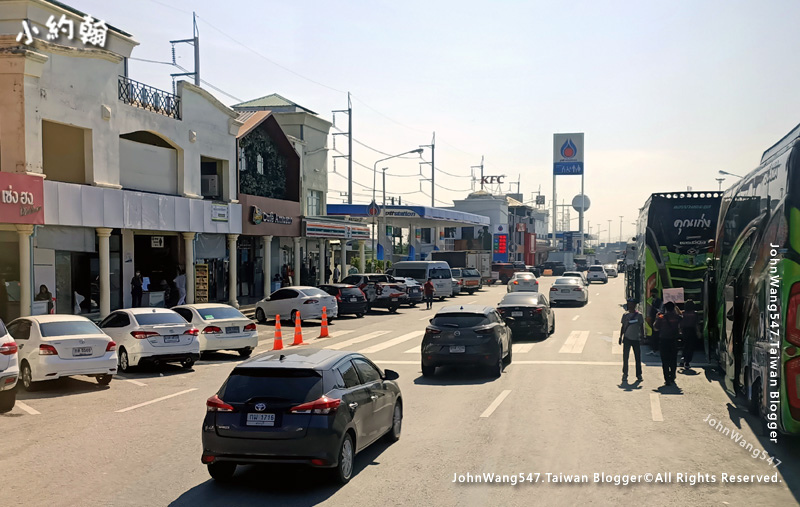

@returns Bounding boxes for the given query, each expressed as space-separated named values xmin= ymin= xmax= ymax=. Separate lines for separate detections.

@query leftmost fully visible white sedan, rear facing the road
xmin=8 ymin=315 xmax=117 ymax=391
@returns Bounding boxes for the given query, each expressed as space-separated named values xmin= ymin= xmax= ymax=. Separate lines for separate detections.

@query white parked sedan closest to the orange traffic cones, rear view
xmin=172 ymin=303 xmax=258 ymax=357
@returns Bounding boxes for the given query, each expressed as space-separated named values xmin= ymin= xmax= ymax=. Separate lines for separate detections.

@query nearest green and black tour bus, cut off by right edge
xmin=705 ymin=125 xmax=800 ymax=440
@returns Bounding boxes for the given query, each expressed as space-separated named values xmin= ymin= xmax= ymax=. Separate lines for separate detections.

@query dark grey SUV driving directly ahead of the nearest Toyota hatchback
xmin=422 ymin=305 xmax=511 ymax=377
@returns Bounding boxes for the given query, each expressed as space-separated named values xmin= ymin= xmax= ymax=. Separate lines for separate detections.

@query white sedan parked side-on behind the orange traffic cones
xmin=256 ymin=286 xmax=339 ymax=322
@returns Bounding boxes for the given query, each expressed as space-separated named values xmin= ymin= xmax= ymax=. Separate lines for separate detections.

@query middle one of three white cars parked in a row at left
xmin=100 ymin=308 xmax=200 ymax=371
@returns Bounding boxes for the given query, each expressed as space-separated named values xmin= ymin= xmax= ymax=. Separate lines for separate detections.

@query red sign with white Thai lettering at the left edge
xmin=0 ymin=172 xmax=44 ymax=225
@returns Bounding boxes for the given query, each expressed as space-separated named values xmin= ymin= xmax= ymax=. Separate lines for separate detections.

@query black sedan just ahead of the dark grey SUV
xmin=497 ymin=292 xmax=556 ymax=338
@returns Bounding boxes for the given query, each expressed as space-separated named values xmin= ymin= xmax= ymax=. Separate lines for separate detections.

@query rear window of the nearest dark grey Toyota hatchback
xmin=219 ymin=368 xmax=323 ymax=403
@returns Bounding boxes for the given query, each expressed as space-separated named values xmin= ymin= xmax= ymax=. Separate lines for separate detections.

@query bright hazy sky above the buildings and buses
xmin=64 ymin=0 xmax=800 ymax=241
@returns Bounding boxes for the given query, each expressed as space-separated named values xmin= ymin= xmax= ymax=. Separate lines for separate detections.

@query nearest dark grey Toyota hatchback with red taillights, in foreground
xmin=201 ymin=348 xmax=403 ymax=483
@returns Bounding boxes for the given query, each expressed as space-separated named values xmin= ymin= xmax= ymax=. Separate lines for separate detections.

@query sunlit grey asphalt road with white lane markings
xmin=0 ymin=278 xmax=800 ymax=506
